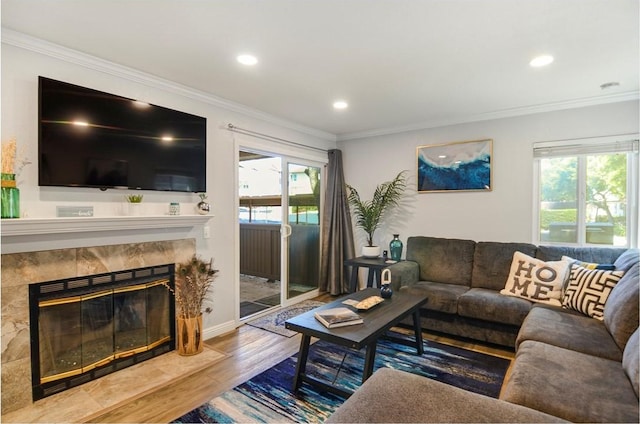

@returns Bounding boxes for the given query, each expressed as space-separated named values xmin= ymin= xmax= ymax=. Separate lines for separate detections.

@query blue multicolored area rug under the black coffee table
xmin=174 ymin=334 xmax=509 ymax=423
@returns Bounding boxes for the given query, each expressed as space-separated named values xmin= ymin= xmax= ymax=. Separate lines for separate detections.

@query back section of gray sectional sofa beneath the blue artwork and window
xmin=389 ymin=237 xmax=626 ymax=347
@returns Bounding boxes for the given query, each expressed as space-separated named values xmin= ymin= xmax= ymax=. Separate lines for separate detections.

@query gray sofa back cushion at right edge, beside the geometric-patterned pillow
xmin=604 ymin=259 xmax=640 ymax=350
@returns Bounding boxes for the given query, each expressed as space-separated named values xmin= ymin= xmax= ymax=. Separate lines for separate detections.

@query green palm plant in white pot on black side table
xmin=347 ymin=171 xmax=407 ymax=258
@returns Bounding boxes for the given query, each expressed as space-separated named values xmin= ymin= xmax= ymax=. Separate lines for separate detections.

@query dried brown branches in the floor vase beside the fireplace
xmin=165 ymin=255 xmax=218 ymax=318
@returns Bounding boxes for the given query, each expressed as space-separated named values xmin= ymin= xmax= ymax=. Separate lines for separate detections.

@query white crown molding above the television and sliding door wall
xmin=2 ymin=27 xmax=336 ymax=142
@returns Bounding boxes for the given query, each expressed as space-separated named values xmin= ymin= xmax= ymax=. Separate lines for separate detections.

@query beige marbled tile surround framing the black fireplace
xmin=1 ymin=239 xmax=200 ymax=419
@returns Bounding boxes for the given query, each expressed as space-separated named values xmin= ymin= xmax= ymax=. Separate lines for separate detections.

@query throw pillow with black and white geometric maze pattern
xmin=562 ymin=265 xmax=624 ymax=321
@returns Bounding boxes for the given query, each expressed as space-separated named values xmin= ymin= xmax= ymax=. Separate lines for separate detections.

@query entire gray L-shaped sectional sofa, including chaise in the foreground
xmin=329 ymin=237 xmax=640 ymax=423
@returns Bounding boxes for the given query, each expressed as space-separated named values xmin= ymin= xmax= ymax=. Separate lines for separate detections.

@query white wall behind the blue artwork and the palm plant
xmin=338 ymin=102 xmax=638 ymax=251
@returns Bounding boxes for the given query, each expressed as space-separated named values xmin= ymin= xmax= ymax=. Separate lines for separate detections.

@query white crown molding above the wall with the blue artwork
xmin=336 ymin=90 xmax=640 ymax=141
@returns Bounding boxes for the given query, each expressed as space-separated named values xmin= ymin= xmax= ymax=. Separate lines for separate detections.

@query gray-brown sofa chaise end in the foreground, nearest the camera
xmin=325 ymin=368 xmax=562 ymax=423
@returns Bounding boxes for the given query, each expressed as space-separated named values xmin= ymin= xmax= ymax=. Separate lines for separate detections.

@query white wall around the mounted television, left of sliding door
xmin=2 ymin=39 xmax=335 ymax=336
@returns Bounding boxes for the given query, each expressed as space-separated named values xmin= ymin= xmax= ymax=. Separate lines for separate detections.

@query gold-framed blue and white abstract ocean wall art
xmin=416 ymin=139 xmax=493 ymax=193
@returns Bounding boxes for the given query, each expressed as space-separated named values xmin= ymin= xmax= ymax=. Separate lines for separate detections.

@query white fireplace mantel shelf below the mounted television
xmin=1 ymin=215 xmax=212 ymax=238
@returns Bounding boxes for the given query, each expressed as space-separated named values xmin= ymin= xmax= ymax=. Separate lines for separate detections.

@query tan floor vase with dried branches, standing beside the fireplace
xmin=165 ymin=255 xmax=218 ymax=355
